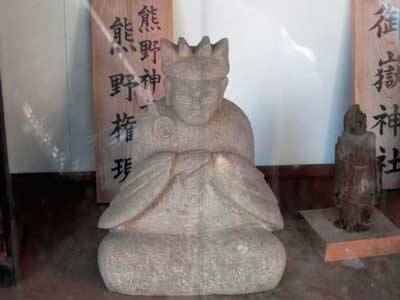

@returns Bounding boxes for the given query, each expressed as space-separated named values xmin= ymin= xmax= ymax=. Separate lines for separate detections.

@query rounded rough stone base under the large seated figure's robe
xmin=98 ymin=227 xmax=286 ymax=295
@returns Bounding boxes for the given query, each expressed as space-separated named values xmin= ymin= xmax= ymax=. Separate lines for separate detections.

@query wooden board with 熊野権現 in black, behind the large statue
xmin=92 ymin=0 xmax=172 ymax=203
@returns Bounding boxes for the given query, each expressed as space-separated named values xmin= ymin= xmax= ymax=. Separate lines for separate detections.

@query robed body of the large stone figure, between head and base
xmin=99 ymin=100 xmax=283 ymax=234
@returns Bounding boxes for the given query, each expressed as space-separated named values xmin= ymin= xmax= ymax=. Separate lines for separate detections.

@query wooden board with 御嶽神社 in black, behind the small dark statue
xmin=353 ymin=0 xmax=400 ymax=189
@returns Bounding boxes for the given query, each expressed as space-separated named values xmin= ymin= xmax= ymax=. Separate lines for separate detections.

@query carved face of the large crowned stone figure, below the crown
xmin=166 ymin=78 xmax=228 ymax=126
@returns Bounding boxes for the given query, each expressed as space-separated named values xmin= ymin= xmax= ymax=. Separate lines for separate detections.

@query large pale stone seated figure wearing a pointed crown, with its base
xmin=98 ymin=37 xmax=286 ymax=295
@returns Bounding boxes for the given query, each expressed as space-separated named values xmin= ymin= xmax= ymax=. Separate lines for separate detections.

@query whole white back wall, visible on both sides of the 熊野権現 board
xmin=0 ymin=0 xmax=351 ymax=173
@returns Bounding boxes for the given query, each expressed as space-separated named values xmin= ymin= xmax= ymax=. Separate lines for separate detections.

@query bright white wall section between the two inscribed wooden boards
xmin=175 ymin=0 xmax=352 ymax=165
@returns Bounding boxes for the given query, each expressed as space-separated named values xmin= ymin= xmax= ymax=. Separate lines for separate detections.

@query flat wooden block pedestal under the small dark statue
xmin=300 ymin=207 xmax=400 ymax=262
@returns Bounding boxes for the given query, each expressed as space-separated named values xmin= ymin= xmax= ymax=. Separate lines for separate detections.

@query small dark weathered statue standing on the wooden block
xmin=335 ymin=104 xmax=382 ymax=231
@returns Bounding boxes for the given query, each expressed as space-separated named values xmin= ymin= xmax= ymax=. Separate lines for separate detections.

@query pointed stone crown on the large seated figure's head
xmin=161 ymin=36 xmax=229 ymax=80
